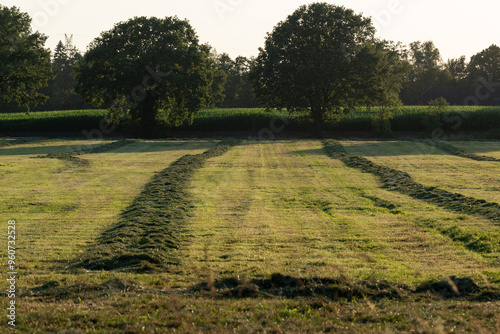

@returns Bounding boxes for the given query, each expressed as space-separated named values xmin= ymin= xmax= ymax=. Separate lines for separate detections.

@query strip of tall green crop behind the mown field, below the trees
xmin=0 ymin=107 xmax=500 ymax=134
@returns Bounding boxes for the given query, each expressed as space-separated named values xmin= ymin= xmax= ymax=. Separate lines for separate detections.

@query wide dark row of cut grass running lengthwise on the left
xmin=72 ymin=141 xmax=240 ymax=270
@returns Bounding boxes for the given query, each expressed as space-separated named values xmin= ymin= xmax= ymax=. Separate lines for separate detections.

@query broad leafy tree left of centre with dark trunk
xmin=75 ymin=17 xmax=212 ymax=135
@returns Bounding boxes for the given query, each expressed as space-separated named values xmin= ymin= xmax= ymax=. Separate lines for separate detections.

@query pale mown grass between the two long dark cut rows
xmin=189 ymin=141 xmax=499 ymax=283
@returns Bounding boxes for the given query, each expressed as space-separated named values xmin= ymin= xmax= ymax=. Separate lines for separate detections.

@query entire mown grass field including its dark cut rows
xmin=0 ymin=138 xmax=500 ymax=333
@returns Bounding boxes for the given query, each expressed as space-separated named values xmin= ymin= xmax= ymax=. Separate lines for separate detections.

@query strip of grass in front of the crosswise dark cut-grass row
xmin=13 ymin=292 xmax=500 ymax=333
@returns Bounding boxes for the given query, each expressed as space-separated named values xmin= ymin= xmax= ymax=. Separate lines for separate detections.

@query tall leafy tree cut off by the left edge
xmin=0 ymin=5 xmax=53 ymax=110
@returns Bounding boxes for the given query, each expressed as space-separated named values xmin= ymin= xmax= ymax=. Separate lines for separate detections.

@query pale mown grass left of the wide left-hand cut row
xmin=0 ymin=139 xmax=214 ymax=276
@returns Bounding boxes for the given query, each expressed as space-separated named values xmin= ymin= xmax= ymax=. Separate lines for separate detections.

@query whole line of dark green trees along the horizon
xmin=0 ymin=3 xmax=500 ymax=131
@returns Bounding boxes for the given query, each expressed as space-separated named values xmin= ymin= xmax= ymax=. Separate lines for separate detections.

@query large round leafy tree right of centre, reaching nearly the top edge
xmin=250 ymin=3 xmax=402 ymax=125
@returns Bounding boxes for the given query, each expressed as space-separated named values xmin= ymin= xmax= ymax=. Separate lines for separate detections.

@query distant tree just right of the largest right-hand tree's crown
xmin=401 ymin=41 xmax=452 ymax=105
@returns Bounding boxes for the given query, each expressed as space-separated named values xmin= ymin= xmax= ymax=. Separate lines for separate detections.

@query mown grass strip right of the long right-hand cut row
xmin=342 ymin=140 xmax=500 ymax=204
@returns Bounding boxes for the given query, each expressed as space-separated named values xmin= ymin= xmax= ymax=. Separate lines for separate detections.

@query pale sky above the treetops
xmin=0 ymin=0 xmax=500 ymax=61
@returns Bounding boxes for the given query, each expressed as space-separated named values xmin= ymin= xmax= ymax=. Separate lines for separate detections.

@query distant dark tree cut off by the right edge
xmin=467 ymin=44 xmax=500 ymax=85
